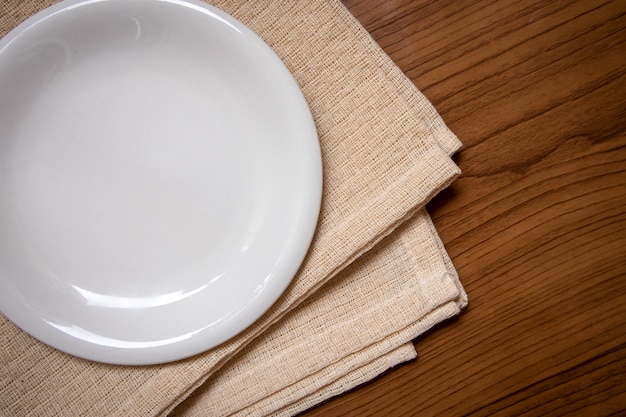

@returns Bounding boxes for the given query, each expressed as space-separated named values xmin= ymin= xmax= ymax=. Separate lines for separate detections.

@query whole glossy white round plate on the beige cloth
xmin=0 ymin=0 xmax=322 ymax=364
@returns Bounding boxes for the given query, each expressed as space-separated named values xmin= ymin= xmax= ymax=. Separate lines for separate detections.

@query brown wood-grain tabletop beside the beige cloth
xmin=305 ymin=0 xmax=626 ymax=416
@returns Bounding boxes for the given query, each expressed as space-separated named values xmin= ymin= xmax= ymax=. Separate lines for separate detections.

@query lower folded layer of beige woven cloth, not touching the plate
xmin=172 ymin=210 xmax=467 ymax=416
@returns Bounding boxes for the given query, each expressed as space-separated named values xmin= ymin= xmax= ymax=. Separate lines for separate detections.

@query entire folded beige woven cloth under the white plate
xmin=0 ymin=0 xmax=466 ymax=416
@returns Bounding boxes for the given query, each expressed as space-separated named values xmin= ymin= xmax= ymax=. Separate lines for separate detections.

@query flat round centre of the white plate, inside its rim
xmin=1 ymin=47 xmax=263 ymax=295
